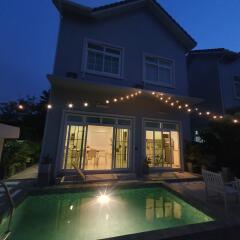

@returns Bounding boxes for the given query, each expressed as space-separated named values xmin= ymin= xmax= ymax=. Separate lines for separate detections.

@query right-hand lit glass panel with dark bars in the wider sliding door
xmin=115 ymin=128 xmax=129 ymax=168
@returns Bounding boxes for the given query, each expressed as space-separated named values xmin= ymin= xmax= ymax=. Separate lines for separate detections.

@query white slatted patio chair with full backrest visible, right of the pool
xmin=202 ymin=169 xmax=238 ymax=207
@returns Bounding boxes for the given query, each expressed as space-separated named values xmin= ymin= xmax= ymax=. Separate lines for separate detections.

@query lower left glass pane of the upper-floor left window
xmin=87 ymin=50 xmax=103 ymax=71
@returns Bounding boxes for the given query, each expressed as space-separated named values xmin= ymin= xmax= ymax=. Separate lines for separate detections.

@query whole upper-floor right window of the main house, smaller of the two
xmin=144 ymin=56 xmax=173 ymax=87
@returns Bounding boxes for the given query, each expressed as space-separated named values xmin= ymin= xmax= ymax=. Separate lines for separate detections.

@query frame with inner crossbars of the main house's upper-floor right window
xmin=142 ymin=53 xmax=175 ymax=88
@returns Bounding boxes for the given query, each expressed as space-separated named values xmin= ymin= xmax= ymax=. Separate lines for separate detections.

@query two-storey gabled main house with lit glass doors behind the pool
xmin=39 ymin=0 xmax=197 ymax=184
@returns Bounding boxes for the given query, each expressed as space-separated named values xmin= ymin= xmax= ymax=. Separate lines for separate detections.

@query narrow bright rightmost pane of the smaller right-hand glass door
xmin=171 ymin=131 xmax=181 ymax=168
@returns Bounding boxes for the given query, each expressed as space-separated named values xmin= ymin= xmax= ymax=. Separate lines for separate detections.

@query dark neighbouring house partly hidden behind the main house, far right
xmin=187 ymin=48 xmax=240 ymax=139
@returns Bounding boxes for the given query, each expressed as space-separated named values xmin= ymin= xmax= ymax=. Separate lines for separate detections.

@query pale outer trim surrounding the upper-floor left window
xmin=82 ymin=38 xmax=124 ymax=79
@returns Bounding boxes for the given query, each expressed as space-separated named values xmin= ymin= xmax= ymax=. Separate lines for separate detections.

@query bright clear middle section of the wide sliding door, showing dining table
xmin=84 ymin=126 xmax=113 ymax=170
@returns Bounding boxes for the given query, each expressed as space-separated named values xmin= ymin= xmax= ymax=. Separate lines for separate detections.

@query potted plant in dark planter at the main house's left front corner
xmin=38 ymin=154 xmax=52 ymax=186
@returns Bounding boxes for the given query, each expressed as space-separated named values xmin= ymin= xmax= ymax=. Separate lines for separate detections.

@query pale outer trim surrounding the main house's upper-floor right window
xmin=142 ymin=53 xmax=175 ymax=88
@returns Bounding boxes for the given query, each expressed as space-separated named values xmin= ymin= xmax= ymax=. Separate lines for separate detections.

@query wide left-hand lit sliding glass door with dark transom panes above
xmin=62 ymin=115 xmax=131 ymax=171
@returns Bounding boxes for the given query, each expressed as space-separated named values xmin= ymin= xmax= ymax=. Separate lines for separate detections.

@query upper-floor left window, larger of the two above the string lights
xmin=86 ymin=42 xmax=122 ymax=77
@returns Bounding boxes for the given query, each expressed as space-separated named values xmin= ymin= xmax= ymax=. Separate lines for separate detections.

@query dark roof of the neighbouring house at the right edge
xmin=188 ymin=48 xmax=240 ymax=60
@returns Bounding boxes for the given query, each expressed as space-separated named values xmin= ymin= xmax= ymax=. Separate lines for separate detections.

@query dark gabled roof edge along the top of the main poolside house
xmin=53 ymin=0 xmax=197 ymax=51
